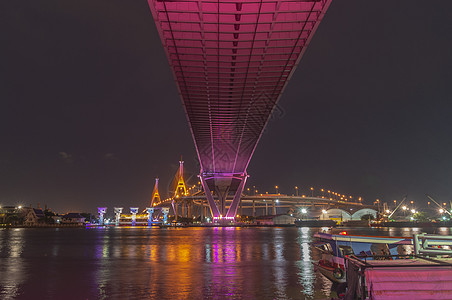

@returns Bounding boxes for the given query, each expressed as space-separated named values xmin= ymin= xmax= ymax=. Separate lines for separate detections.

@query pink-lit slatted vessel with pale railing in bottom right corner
xmin=344 ymin=233 xmax=452 ymax=299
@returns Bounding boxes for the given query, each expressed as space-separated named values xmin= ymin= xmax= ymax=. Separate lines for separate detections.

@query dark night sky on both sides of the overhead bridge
xmin=0 ymin=0 xmax=452 ymax=213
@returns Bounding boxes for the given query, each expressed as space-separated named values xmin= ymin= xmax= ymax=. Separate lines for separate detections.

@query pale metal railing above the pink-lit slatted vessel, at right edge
xmin=413 ymin=233 xmax=452 ymax=256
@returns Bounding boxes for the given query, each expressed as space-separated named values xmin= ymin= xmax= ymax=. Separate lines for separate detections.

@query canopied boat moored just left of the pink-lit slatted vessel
xmin=313 ymin=231 xmax=413 ymax=283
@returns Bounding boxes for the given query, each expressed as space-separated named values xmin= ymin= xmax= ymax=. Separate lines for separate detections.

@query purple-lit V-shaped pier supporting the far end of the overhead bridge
xmin=198 ymin=173 xmax=248 ymax=220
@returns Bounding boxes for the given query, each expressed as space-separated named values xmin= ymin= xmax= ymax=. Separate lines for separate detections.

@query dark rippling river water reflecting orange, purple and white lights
xmin=0 ymin=227 xmax=451 ymax=299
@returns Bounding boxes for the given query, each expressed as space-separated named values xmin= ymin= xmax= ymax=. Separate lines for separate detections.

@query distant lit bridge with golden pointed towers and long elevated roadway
xmin=150 ymin=161 xmax=376 ymax=222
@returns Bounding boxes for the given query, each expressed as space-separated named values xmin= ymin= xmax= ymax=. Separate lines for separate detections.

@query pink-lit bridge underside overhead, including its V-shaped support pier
xmin=148 ymin=0 xmax=331 ymax=218
